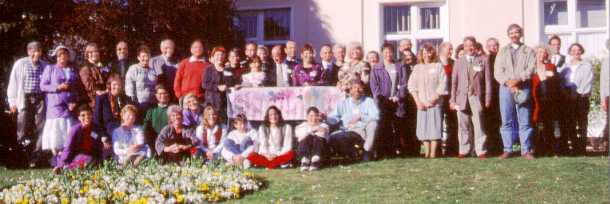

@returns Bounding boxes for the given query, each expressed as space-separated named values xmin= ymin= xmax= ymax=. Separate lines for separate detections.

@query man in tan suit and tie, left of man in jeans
xmin=450 ymin=36 xmax=492 ymax=159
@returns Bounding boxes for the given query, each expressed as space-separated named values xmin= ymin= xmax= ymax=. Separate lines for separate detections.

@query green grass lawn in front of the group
xmin=0 ymin=157 xmax=609 ymax=203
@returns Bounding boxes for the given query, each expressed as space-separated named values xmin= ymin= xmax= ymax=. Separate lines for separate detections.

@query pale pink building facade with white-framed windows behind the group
xmin=235 ymin=0 xmax=608 ymax=56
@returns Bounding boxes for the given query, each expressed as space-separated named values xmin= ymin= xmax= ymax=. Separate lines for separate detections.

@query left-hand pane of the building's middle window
xmin=383 ymin=6 xmax=411 ymax=33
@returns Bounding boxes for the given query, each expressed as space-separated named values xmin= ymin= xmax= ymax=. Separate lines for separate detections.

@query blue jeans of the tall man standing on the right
xmin=499 ymin=82 xmax=533 ymax=154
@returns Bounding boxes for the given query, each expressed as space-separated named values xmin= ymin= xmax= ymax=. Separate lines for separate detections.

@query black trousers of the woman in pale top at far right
xmin=559 ymin=95 xmax=590 ymax=155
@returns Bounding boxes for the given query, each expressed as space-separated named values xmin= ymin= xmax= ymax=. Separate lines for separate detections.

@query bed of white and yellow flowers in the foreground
xmin=0 ymin=160 xmax=262 ymax=203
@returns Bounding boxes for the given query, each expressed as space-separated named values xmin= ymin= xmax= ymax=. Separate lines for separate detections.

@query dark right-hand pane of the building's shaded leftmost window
xmin=264 ymin=9 xmax=290 ymax=40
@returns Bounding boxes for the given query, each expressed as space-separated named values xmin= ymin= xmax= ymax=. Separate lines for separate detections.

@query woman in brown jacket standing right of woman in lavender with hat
xmin=79 ymin=43 xmax=110 ymax=107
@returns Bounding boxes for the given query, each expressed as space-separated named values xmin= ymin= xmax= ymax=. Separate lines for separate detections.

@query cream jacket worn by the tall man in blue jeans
xmin=494 ymin=44 xmax=536 ymax=85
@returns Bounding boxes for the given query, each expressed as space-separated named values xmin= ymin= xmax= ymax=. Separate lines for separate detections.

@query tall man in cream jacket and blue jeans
xmin=494 ymin=24 xmax=536 ymax=160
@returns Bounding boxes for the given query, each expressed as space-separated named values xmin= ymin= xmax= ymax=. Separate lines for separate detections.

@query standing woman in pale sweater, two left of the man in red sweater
xmin=125 ymin=46 xmax=159 ymax=111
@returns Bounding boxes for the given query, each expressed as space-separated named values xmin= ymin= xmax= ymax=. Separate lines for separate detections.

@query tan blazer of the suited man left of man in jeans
xmin=449 ymin=56 xmax=492 ymax=111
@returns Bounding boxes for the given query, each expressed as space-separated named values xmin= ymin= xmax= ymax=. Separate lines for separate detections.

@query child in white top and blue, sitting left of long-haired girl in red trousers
xmin=221 ymin=114 xmax=256 ymax=168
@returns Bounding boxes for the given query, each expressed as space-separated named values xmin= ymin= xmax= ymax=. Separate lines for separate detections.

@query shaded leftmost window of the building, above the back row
xmin=236 ymin=8 xmax=292 ymax=44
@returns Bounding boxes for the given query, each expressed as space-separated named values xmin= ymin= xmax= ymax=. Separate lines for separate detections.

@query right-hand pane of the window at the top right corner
xmin=576 ymin=0 xmax=606 ymax=28
